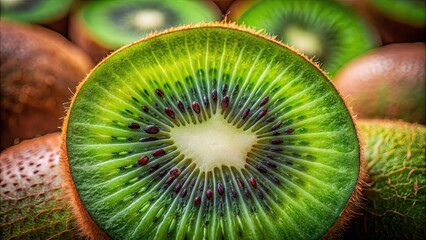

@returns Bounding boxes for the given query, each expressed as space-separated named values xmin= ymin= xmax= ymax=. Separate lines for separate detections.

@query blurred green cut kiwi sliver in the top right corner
xmin=368 ymin=0 xmax=426 ymax=27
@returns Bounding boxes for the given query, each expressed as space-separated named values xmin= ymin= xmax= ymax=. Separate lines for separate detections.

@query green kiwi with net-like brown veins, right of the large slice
xmin=357 ymin=120 xmax=426 ymax=239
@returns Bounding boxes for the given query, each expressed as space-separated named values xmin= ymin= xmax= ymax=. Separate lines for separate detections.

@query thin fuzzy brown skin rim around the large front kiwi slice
xmin=60 ymin=20 xmax=367 ymax=239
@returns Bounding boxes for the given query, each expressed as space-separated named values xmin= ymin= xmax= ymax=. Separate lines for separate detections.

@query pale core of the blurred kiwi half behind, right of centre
xmin=284 ymin=25 xmax=322 ymax=57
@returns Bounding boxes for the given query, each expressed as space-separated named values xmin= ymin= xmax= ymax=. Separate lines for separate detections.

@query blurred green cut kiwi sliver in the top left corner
xmin=0 ymin=0 xmax=72 ymax=23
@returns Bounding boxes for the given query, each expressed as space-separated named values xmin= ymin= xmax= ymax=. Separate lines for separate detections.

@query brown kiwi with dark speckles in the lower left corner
xmin=0 ymin=133 xmax=79 ymax=239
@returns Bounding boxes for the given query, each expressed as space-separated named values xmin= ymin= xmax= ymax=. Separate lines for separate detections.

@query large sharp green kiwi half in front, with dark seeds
xmin=61 ymin=23 xmax=362 ymax=239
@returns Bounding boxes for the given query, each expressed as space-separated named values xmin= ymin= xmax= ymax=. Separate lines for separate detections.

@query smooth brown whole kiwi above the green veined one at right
xmin=334 ymin=43 xmax=426 ymax=124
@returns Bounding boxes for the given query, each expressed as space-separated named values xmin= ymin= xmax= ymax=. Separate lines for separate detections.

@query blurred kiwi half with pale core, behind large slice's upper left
xmin=71 ymin=0 xmax=221 ymax=61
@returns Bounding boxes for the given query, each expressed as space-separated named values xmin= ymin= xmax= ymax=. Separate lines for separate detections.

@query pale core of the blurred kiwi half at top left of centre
xmin=133 ymin=10 xmax=166 ymax=30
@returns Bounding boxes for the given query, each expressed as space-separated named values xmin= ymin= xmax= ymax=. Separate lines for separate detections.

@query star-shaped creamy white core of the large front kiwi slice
xmin=170 ymin=114 xmax=257 ymax=172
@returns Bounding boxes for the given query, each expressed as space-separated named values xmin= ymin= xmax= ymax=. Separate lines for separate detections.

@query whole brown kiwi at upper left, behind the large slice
xmin=0 ymin=20 xmax=93 ymax=149
